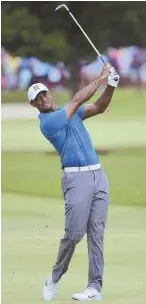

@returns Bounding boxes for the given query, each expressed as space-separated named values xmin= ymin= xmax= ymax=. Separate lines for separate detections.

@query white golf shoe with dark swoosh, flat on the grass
xmin=72 ymin=287 xmax=102 ymax=301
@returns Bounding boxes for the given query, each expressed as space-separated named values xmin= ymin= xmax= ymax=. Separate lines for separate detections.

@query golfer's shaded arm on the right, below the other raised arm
xmin=83 ymin=85 xmax=115 ymax=120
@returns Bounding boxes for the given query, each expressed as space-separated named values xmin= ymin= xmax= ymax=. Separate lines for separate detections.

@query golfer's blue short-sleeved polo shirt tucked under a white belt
xmin=38 ymin=106 xmax=98 ymax=168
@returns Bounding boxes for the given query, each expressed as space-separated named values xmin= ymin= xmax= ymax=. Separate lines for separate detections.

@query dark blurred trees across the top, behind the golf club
xmin=1 ymin=1 xmax=146 ymax=91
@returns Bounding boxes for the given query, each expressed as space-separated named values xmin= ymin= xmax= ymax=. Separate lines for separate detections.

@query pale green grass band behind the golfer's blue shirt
xmin=2 ymin=114 xmax=146 ymax=152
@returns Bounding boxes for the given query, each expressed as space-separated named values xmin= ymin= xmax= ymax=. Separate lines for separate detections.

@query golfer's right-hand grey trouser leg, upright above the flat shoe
xmin=87 ymin=170 xmax=109 ymax=292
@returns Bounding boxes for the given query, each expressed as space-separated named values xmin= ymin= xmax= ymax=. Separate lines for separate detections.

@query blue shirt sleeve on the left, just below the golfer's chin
xmin=43 ymin=107 xmax=68 ymax=135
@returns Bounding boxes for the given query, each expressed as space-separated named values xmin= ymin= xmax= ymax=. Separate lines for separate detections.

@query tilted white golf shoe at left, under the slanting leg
xmin=43 ymin=273 xmax=57 ymax=301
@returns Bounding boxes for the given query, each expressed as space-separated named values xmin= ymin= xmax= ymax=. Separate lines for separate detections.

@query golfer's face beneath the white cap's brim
xmin=34 ymin=91 xmax=53 ymax=112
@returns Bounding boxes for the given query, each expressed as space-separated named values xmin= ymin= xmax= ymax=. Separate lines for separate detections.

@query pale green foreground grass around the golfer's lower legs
xmin=2 ymin=193 xmax=146 ymax=304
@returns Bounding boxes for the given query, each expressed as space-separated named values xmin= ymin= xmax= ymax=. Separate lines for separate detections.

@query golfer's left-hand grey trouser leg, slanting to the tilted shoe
xmin=52 ymin=172 xmax=94 ymax=282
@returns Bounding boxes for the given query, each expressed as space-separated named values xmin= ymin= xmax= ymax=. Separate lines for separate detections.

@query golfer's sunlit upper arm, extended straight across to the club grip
xmin=65 ymin=75 xmax=105 ymax=119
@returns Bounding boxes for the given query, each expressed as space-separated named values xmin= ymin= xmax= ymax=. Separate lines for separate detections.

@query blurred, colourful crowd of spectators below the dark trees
xmin=1 ymin=46 xmax=146 ymax=91
